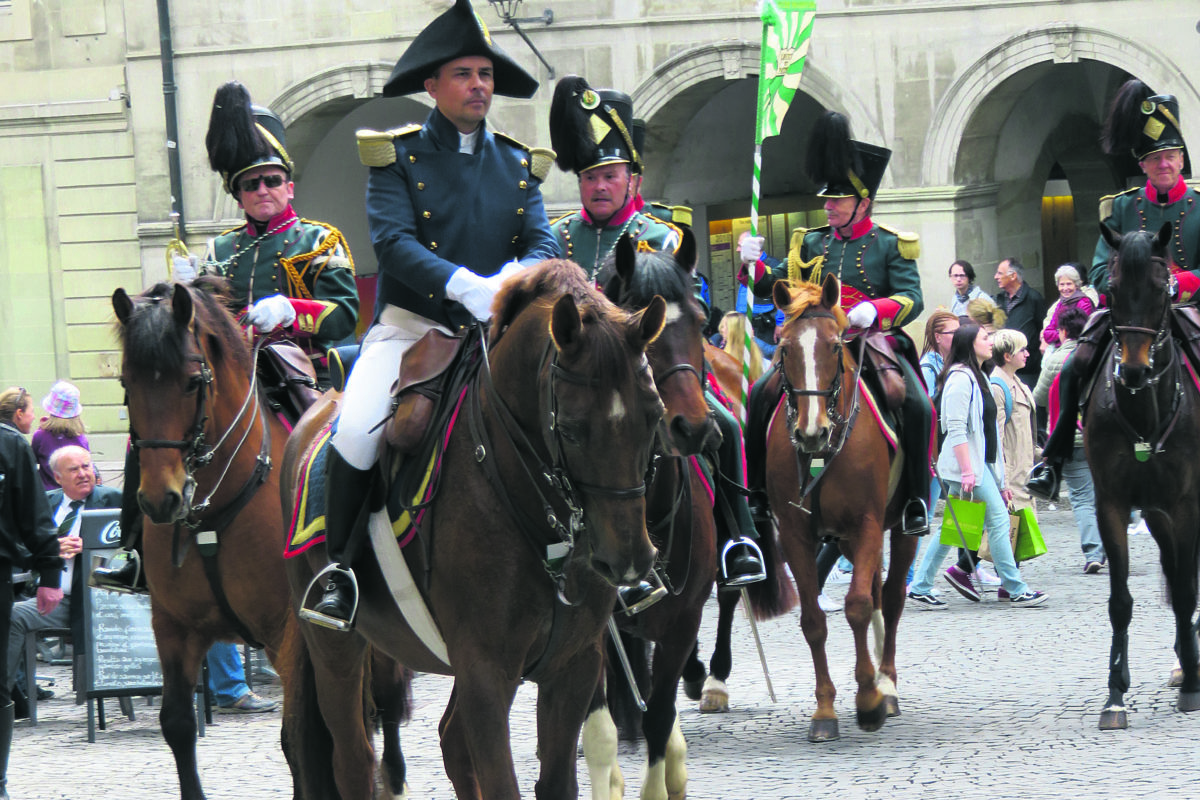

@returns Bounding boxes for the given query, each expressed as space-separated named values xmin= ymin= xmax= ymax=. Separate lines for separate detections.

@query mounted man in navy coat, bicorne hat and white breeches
xmin=300 ymin=0 xmax=556 ymax=631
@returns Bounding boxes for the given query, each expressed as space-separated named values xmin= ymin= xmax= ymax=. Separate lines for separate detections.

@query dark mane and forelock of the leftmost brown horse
xmin=116 ymin=276 xmax=250 ymax=377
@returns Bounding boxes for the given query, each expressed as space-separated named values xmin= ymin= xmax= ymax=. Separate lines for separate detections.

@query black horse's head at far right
xmin=1100 ymin=222 xmax=1174 ymax=391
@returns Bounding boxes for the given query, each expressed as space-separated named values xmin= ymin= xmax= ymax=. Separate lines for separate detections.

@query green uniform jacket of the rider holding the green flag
xmin=754 ymin=218 xmax=925 ymax=330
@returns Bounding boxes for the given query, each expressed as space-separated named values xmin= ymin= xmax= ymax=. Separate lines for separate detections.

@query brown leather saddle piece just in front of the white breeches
xmin=384 ymin=329 xmax=467 ymax=453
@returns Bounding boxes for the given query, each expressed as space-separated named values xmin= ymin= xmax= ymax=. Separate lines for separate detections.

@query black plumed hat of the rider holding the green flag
xmin=805 ymin=112 xmax=892 ymax=199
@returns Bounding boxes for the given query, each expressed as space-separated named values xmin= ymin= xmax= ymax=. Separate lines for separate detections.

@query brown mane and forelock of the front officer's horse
xmin=490 ymin=259 xmax=648 ymax=390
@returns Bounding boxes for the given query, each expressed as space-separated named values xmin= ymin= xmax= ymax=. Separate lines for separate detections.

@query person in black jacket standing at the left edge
xmin=0 ymin=387 xmax=62 ymax=798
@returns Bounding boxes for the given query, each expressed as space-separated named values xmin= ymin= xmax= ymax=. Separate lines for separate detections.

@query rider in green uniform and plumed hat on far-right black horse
xmin=1026 ymin=78 xmax=1200 ymax=500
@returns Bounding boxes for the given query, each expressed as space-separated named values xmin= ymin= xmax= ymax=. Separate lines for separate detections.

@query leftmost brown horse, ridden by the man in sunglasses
xmin=113 ymin=278 xmax=407 ymax=800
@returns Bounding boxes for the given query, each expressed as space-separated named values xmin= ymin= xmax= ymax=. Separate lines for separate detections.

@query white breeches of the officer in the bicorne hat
xmin=330 ymin=306 xmax=450 ymax=470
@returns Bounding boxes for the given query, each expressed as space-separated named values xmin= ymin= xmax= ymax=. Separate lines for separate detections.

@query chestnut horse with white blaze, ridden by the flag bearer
xmin=767 ymin=275 xmax=917 ymax=741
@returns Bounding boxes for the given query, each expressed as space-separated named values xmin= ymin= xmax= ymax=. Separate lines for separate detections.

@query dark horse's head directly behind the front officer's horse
xmin=601 ymin=228 xmax=719 ymax=456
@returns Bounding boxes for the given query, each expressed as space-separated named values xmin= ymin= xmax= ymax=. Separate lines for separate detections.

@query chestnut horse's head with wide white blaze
xmin=774 ymin=273 xmax=846 ymax=453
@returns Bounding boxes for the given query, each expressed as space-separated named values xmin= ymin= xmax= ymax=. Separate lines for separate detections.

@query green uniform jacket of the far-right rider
xmin=1088 ymin=178 xmax=1200 ymax=297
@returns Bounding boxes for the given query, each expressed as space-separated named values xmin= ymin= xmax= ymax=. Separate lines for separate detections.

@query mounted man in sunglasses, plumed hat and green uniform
xmin=92 ymin=80 xmax=359 ymax=591
